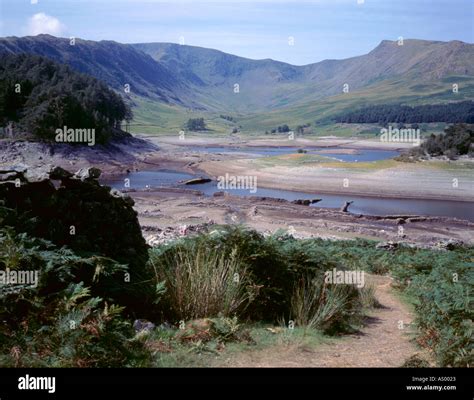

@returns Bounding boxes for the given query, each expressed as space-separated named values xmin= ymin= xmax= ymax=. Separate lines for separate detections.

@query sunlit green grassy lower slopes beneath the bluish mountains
xmin=132 ymin=76 xmax=474 ymax=136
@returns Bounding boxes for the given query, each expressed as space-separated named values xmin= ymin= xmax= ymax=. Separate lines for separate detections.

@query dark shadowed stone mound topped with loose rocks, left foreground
xmin=0 ymin=167 xmax=148 ymax=276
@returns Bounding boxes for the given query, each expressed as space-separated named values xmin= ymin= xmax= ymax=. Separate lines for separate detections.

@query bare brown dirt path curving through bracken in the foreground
xmin=218 ymin=276 xmax=417 ymax=367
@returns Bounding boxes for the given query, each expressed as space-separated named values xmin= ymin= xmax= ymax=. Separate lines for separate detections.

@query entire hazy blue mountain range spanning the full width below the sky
xmin=0 ymin=35 xmax=474 ymax=113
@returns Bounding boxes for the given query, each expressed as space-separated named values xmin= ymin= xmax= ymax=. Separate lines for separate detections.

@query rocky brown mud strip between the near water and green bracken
xmin=128 ymin=189 xmax=474 ymax=247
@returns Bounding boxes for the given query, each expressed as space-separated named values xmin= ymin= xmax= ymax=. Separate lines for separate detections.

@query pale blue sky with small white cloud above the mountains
xmin=0 ymin=0 xmax=474 ymax=65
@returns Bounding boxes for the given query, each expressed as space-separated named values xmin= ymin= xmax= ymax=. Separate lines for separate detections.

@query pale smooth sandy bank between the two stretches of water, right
xmin=199 ymin=159 xmax=474 ymax=202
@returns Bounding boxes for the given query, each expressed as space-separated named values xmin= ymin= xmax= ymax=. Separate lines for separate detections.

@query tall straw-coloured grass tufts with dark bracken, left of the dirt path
xmin=150 ymin=227 xmax=372 ymax=332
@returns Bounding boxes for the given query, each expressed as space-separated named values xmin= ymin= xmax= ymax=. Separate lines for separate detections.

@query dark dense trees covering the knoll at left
xmin=0 ymin=54 xmax=132 ymax=143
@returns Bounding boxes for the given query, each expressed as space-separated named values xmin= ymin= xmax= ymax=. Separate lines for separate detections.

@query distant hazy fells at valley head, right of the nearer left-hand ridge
xmin=132 ymin=39 xmax=474 ymax=112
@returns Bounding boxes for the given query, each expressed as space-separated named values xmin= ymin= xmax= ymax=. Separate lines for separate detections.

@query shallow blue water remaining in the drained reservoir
xmin=103 ymin=147 xmax=474 ymax=221
